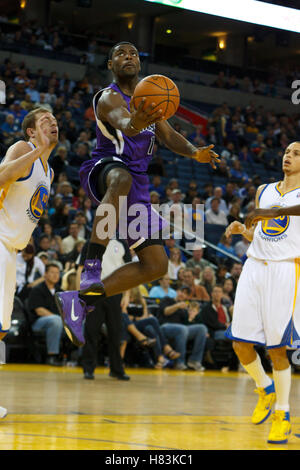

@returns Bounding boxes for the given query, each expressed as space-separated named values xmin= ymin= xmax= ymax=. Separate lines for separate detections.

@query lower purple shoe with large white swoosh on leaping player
xmin=55 ymin=290 xmax=89 ymax=346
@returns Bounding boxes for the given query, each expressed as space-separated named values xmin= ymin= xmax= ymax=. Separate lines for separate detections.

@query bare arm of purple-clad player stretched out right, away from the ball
xmin=156 ymin=121 xmax=220 ymax=168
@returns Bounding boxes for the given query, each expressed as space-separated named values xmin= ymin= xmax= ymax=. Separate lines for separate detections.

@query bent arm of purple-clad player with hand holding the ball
xmin=97 ymin=89 xmax=162 ymax=137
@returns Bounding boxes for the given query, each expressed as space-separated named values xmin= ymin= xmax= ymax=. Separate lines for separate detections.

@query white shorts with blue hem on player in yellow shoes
xmin=226 ymin=258 xmax=300 ymax=348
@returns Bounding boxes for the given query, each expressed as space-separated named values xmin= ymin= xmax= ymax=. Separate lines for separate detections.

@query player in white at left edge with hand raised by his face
xmin=0 ymin=108 xmax=58 ymax=417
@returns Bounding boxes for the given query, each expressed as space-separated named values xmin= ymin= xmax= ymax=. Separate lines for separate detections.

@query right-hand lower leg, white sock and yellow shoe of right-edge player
xmin=268 ymin=346 xmax=292 ymax=444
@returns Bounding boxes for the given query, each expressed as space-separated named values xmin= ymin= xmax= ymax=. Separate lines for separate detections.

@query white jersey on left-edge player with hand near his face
xmin=0 ymin=142 xmax=52 ymax=250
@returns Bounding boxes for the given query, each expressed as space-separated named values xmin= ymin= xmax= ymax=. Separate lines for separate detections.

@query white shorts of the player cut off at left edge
xmin=0 ymin=240 xmax=17 ymax=332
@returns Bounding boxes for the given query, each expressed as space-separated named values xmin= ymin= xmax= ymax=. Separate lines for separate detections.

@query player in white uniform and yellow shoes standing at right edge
xmin=226 ymin=142 xmax=300 ymax=443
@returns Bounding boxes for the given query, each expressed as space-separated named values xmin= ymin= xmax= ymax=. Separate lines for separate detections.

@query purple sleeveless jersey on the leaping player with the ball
xmin=92 ymin=83 xmax=155 ymax=173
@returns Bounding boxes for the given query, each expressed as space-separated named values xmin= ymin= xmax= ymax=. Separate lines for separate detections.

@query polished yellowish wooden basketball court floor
xmin=0 ymin=364 xmax=300 ymax=450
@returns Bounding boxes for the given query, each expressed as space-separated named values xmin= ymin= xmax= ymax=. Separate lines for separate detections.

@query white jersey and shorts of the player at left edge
xmin=0 ymin=142 xmax=53 ymax=332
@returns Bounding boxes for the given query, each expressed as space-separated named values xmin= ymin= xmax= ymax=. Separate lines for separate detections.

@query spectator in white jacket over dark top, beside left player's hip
xmin=16 ymin=245 xmax=45 ymax=301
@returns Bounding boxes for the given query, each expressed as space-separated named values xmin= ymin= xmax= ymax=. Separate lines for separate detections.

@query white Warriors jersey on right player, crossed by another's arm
xmin=247 ymin=182 xmax=300 ymax=261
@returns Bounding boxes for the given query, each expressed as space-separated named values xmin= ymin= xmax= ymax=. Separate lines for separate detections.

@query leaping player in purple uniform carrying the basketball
xmin=56 ymin=42 xmax=219 ymax=345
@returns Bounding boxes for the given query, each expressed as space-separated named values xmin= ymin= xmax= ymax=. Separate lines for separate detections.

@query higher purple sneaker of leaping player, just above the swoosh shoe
xmin=79 ymin=259 xmax=104 ymax=295
